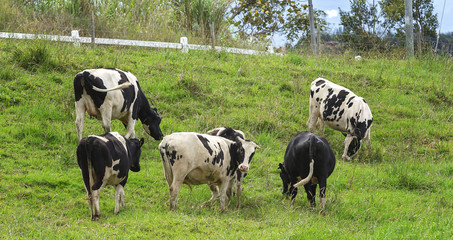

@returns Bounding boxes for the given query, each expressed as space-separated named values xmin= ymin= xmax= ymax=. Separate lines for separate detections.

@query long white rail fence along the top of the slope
xmin=0 ymin=30 xmax=282 ymax=55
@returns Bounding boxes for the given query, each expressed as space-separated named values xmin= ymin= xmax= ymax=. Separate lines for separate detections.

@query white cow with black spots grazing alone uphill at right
xmin=307 ymin=78 xmax=373 ymax=160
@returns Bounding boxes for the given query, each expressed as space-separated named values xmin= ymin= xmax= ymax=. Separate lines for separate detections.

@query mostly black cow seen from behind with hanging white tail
xmin=278 ymin=132 xmax=335 ymax=212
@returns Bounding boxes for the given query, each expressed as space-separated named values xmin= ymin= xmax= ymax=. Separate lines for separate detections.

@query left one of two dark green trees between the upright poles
xmin=340 ymin=0 xmax=388 ymax=50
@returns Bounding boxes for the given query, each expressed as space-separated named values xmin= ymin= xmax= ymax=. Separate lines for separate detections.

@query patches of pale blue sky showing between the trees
xmin=273 ymin=0 xmax=453 ymax=47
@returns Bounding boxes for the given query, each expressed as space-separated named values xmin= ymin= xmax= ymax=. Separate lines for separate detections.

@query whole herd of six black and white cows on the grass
xmin=74 ymin=69 xmax=373 ymax=220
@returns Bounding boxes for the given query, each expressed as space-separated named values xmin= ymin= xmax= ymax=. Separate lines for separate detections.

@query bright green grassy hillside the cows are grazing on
xmin=0 ymin=40 xmax=453 ymax=239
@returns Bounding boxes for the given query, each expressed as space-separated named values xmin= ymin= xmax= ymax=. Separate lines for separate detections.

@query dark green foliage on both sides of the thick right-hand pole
xmin=340 ymin=0 xmax=438 ymax=52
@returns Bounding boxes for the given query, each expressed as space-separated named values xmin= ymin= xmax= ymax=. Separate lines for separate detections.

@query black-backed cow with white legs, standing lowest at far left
xmin=77 ymin=132 xmax=144 ymax=221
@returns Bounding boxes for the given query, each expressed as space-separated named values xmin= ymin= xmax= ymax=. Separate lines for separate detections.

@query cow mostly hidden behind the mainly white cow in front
xmin=208 ymin=127 xmax=247 ymax=208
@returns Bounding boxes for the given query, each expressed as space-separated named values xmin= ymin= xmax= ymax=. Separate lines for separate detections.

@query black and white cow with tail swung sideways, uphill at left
xmin=74 ymin=69 xmax=163 ymax=141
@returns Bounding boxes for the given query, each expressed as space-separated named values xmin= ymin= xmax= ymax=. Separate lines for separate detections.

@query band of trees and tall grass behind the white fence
xmin=0 ymin=0 xmax=452 ymax=54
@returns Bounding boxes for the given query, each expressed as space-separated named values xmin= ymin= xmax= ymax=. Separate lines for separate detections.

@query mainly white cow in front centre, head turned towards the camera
xmin=159 ymin=128 xmax=259 ymax=211
